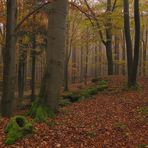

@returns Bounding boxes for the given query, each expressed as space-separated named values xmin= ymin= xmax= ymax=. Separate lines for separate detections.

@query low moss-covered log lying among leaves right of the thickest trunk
xmin=61 ymin=80 xmax=108 ymax=103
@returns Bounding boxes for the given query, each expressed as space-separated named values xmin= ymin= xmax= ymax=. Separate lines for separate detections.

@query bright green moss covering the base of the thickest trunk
xmin=28 ymin=101 xmax=55 ymax=122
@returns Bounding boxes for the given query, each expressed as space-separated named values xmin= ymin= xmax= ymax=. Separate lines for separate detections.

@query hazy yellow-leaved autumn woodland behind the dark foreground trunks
xmin=0 ymin=0 xmax=148 ymax=98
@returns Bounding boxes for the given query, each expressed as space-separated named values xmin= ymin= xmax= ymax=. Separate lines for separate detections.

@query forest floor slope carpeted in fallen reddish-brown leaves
xmin=0 ymin=76 xmax=148 ymax=148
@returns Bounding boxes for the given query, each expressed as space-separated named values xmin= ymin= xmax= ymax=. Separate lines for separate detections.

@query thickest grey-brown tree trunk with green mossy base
xmin=31 ymin=0 xmax=68 ymax=120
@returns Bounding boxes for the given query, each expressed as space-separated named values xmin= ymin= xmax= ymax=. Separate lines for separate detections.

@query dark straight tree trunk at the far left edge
xmin=1 ymin=0 xmax=17 ymax=117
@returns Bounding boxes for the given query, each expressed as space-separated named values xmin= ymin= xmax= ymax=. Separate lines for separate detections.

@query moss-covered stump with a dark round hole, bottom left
xmin=5 ymin=116 xmax=33 ymax=145
